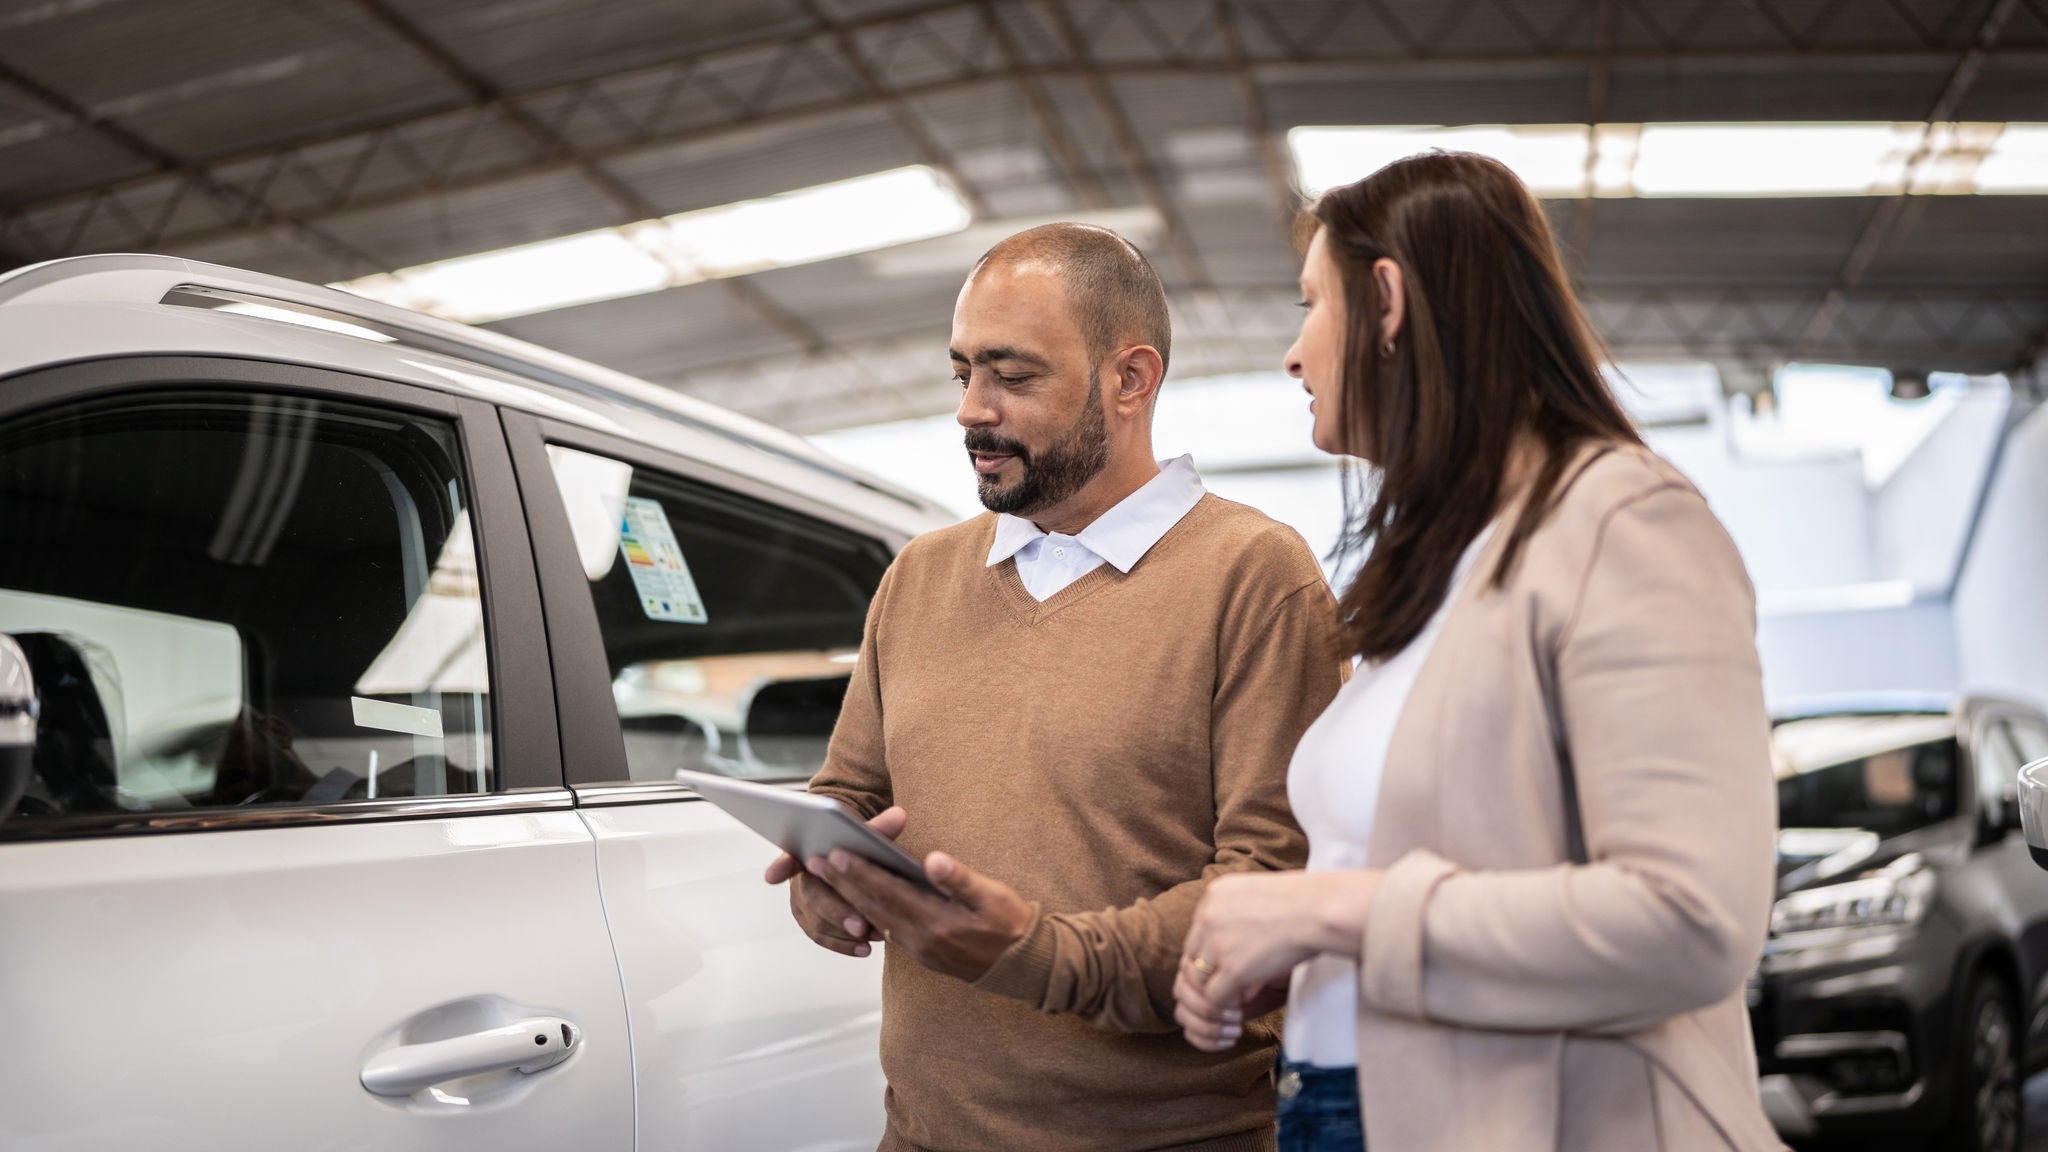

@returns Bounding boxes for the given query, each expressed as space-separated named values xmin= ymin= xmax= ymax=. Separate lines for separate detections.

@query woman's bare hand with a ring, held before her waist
xmin=1174 ymin=871 xmax=1380 ymax=1052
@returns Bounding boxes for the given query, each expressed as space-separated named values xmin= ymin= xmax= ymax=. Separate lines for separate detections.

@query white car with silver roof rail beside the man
xmin=0 ymin=256 xmax=946 ymax=1152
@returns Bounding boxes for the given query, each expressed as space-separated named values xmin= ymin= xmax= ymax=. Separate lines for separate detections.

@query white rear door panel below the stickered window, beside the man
xmin=582 ymin=795 xmax=885 ymax=1152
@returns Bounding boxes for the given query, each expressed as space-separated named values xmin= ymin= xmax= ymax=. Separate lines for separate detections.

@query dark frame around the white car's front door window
xmin=0 ymin=355 xmax=567 ymax=842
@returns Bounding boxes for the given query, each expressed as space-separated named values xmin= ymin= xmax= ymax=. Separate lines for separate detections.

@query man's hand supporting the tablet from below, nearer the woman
xmin=807 ymin=849 xmax=1038 ymax=984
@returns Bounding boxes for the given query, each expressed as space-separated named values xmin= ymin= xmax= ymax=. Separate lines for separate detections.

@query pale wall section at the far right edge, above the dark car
xmin=1954 ymin=406 xmax=2048 ymax=705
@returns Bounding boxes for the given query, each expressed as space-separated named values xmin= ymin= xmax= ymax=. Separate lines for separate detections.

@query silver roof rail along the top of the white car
xmin=0 ymin=252 xmax=932 ymax=510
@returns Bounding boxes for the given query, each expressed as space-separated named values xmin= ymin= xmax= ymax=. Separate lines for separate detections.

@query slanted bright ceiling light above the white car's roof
xmin=334 ymin=166 xmax=973 ymax=324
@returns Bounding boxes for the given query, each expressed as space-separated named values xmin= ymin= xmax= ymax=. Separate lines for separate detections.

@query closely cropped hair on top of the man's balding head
xmin=967 ymin=223 xmax=1174 ymax=373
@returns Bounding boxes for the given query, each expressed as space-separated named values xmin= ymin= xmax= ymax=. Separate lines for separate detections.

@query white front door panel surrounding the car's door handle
xmin=0 ymin=795 xmax=633 ymax=1152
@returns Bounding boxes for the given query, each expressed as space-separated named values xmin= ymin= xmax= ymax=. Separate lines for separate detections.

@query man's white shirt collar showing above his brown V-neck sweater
xmin=987 ymin=455 xmax=1206 ymax=603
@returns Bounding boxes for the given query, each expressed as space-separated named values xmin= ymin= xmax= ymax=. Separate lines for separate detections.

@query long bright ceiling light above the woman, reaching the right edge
xmin=1288 ymin=121 xmax=2048 ymax=197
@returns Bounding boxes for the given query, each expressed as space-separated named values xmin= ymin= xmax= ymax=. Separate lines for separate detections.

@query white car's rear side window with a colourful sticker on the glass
xmin=549 ymin=445 xmax=889 ymax=781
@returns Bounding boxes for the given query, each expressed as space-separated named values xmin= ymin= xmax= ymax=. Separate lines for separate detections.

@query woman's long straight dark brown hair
xmin=1303 ymin=152 xmax=1642 ymax=660
